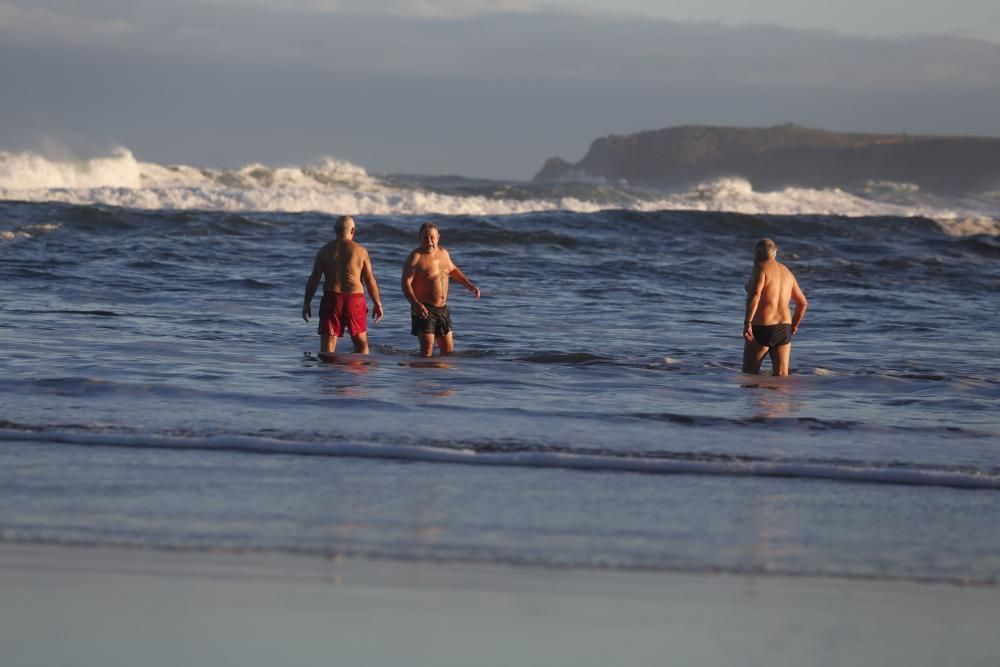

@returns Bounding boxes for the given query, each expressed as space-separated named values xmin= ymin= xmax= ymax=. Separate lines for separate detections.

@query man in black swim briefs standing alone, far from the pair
xmin=743 ymin=239 xmax=809 ymax=375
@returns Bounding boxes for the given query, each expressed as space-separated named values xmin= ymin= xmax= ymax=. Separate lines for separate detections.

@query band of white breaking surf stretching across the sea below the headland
xmin=0 ymin=148 xmax=1000 ymax=235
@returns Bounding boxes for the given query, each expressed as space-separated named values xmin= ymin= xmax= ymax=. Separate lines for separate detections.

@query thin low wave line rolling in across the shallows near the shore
xmin=0 ymin=422 xmax=1000 ymax=490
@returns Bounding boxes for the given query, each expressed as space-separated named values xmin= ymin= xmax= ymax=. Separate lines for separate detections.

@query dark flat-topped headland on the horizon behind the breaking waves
xmin=533 ymin=124 xmax=1000 ymax=194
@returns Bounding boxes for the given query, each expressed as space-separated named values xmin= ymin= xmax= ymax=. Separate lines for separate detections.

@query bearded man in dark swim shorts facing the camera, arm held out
xmin=400 ymin=223 xmax=480 ymax=357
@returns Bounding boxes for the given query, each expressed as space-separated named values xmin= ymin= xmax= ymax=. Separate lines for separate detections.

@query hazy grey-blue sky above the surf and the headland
xmin=0 ymin=0 xmax=1000 ymax=179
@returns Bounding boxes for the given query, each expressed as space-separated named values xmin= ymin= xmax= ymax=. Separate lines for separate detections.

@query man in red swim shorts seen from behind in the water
xmin=302 ymin=215 xmax=382 ymax=354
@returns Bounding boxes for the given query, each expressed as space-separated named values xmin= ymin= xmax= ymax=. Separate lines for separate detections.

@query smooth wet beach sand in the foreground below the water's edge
xmin=0 ymin=544 xmax=1000 ymax=667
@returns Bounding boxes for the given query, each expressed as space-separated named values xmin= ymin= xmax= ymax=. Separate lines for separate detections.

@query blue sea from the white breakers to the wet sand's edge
xmin=0 ymin=152 xmax=1000 ymax=582
